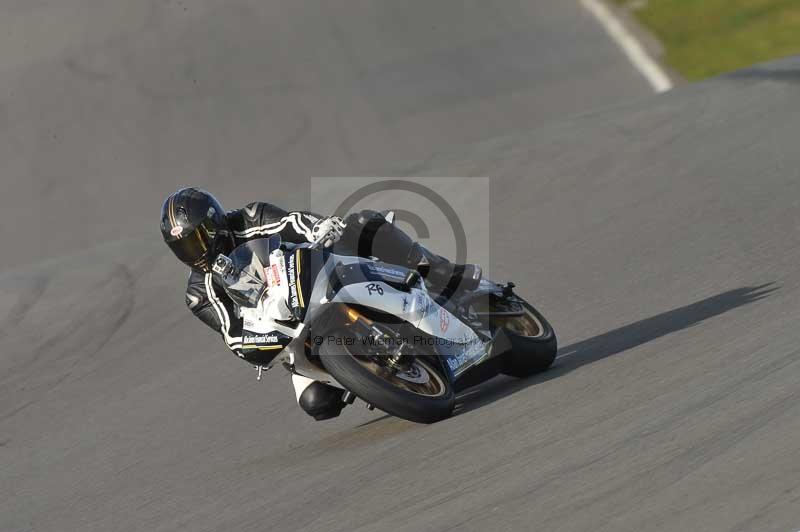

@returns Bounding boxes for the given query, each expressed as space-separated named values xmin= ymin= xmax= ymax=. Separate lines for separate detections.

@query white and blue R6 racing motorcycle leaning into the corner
xmin=213 ymin=235 xmax=557 ymax=423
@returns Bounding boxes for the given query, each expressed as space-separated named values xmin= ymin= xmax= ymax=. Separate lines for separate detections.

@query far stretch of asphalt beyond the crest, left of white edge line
xmin=0 ymin=0 xmax=650 ymax=269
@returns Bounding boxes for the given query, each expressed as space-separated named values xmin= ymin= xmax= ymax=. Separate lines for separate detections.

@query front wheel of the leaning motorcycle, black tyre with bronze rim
xmin=319 ymin=332 xmax=455 ymax=423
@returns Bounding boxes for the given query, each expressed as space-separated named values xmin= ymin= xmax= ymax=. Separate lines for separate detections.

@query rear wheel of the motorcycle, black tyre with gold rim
xmin=494 ymin=297 xmax=558 ymax=377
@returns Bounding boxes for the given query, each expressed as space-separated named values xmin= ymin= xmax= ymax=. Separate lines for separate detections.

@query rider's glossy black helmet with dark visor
xmin=161 ymin=188 xmax=233 ymax=272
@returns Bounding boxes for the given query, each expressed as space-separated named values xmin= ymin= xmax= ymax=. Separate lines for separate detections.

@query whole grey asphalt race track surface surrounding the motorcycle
xmin=0 ymin=1 xmax=800 ymax=531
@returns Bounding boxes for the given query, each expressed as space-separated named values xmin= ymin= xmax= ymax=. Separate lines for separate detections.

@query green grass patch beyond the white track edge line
xmin=617 ymin=0 xmax=800 ymax=80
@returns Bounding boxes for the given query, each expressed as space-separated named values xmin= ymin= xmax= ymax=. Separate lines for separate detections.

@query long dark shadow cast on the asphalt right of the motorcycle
xmin=457 ymin=283 xmax=779 ymax=414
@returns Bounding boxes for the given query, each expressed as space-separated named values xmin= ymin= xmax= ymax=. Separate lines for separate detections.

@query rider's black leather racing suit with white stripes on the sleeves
xmin=181 ymin=202 xmax=424 ymax=365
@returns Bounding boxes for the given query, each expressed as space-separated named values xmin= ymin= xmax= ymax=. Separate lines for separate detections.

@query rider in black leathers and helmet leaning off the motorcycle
xmin=161 ymin=188 xmax=480 ymax=420
